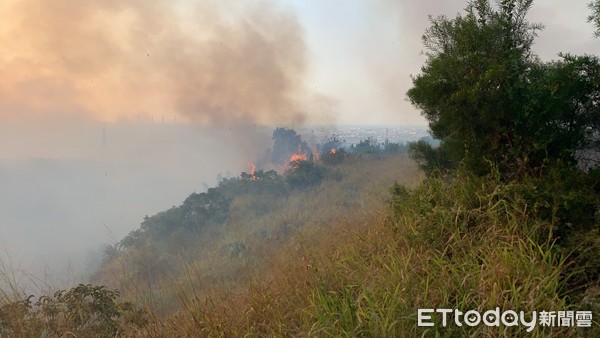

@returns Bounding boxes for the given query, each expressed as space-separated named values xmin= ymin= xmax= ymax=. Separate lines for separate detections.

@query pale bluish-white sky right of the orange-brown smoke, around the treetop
xmin=286 ymin=0 xmax=600 ymax=124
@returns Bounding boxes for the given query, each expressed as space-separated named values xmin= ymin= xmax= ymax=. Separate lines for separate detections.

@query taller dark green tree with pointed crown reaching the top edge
xmin=407 ymin=0 xmax=541 ymax=173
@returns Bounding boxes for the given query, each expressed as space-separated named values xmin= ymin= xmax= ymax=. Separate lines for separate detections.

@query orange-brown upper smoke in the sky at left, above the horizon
xmin=0 ymin=0 xmax=311 ymax=126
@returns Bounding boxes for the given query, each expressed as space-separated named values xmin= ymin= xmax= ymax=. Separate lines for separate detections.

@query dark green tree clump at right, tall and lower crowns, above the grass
xmin=407 ymin=0 xmax=600 ymax=178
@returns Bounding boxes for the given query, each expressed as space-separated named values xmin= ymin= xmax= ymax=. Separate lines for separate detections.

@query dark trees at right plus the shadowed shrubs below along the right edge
xmin=408 ymin=0 xmax=600 ymax=310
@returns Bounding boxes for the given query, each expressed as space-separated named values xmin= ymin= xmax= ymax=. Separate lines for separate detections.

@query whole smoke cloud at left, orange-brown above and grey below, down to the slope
xmin=0 ymin=0 xmax=331 ymax=288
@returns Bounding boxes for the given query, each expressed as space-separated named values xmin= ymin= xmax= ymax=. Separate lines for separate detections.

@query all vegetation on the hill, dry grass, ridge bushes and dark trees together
xmin=0 ymin=0 xmax=600 ymax=337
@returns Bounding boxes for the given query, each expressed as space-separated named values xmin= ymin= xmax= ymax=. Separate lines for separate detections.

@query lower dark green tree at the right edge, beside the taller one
xmin=518 ymin=54 xmax=600 ymax=172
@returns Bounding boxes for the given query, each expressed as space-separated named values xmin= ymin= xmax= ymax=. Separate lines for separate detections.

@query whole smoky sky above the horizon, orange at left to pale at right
xmin=0 ymin=0 xmax=600 ymax=125
